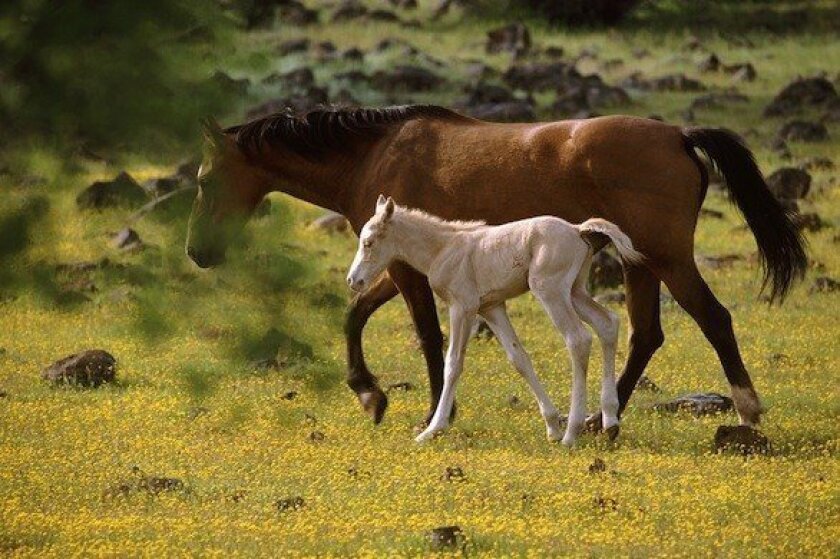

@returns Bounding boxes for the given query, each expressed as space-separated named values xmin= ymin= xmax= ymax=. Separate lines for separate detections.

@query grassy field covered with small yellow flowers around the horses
xmin=0 ymin=2 xmax=840 ymax=557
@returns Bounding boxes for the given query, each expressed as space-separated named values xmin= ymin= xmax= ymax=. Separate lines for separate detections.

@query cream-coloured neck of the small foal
xmin=392 ymin=214 xmax=457 ymax=274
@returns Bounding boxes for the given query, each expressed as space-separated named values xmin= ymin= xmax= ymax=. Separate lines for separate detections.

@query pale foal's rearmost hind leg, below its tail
xmin=572 ymin=284 xmax=619 ymax=439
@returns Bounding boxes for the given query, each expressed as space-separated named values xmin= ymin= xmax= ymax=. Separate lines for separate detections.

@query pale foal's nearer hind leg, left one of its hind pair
xmin=530 ymin=277 xmax=592 ymax=446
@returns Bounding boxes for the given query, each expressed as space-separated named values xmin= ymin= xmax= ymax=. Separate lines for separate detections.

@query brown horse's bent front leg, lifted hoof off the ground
xmin=344 ymin=274 xmax=398 ymax=423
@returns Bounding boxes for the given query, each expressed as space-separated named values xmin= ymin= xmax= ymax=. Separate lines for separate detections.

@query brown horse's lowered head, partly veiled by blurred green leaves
xmin=186 ymin=119 xmax=271 ymax=268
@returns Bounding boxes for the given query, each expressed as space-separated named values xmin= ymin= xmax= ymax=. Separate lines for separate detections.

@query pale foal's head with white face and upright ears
xmin=347 ymin=194 xmax=396 ymax=291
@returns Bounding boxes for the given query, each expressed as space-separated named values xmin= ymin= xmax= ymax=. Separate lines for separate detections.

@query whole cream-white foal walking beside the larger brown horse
xmin=347 ymin=196 xmax=642 ymax=446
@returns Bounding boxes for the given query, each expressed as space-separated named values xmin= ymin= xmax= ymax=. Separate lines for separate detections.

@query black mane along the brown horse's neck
xmin=225 ymin=105 xmax=463 ymax=157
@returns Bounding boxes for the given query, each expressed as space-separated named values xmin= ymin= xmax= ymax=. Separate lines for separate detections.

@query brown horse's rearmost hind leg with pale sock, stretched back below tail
xmin=662 ymin=257 xmax=763 ymax=426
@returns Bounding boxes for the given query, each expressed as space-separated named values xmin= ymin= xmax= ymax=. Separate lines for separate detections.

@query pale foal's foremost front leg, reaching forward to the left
xmin=415 ymin=303 xmax=476 ymax=443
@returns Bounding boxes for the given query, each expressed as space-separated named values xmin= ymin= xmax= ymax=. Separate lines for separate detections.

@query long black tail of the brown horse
xmin=683 ymin=127 xmax=808 ymax=302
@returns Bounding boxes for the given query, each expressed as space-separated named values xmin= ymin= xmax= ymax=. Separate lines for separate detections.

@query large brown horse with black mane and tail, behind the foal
xmin=187 ymin=106 xmax=807 ymax=425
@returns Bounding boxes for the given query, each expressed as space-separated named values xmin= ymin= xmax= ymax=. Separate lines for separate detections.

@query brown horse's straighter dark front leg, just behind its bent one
xmin=388 ymin=263 xmax=455 ymax=428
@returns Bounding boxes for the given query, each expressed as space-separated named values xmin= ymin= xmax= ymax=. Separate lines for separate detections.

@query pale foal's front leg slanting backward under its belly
xmin=481 ymin=304 xmax=562 ymax=441
